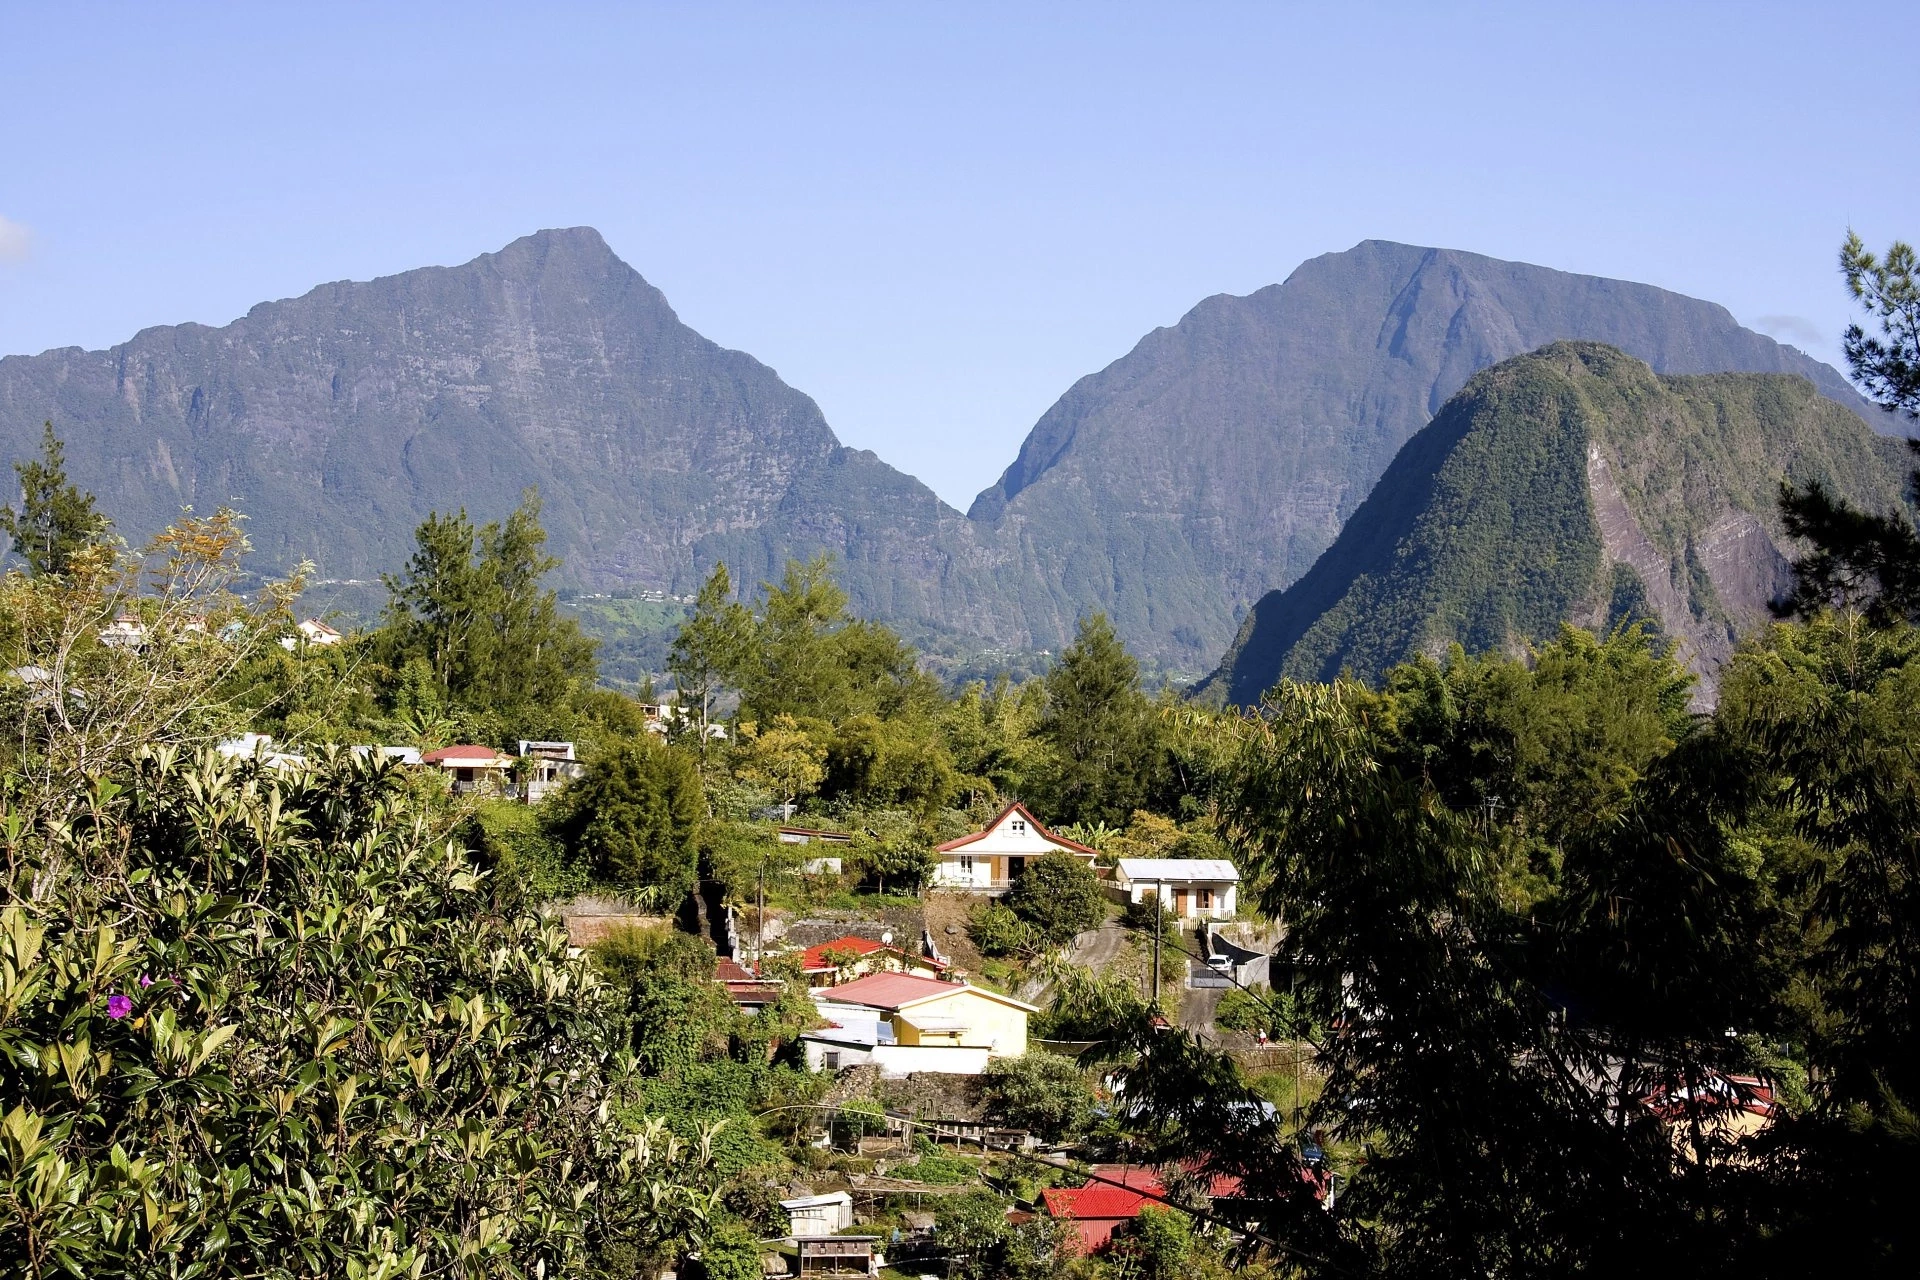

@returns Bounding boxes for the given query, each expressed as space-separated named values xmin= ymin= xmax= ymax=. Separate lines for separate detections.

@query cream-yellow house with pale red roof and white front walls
xmin=801 ymin=973 xmax=1039 ymax=1077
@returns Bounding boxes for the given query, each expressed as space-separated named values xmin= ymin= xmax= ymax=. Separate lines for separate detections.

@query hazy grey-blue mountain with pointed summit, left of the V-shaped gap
xmin=0 ymin=228 xmax=993 ymax=637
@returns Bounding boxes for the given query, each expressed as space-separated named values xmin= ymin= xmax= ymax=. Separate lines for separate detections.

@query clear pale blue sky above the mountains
xmin=0 ymin=0 xmax=1920 ymax=507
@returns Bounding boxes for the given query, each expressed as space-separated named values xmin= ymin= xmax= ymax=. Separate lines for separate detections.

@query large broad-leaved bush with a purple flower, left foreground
xmin=0 ymin=748 xmax=697 ymax=1276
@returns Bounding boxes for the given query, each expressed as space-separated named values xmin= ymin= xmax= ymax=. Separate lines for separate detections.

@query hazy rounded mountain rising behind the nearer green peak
xmin=968 ymin=240 xmax=1862 ymax=666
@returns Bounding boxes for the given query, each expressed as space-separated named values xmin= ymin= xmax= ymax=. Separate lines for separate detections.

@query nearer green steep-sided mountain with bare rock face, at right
xmin=1206 ymin=342 xmax=1903 ymax=704
